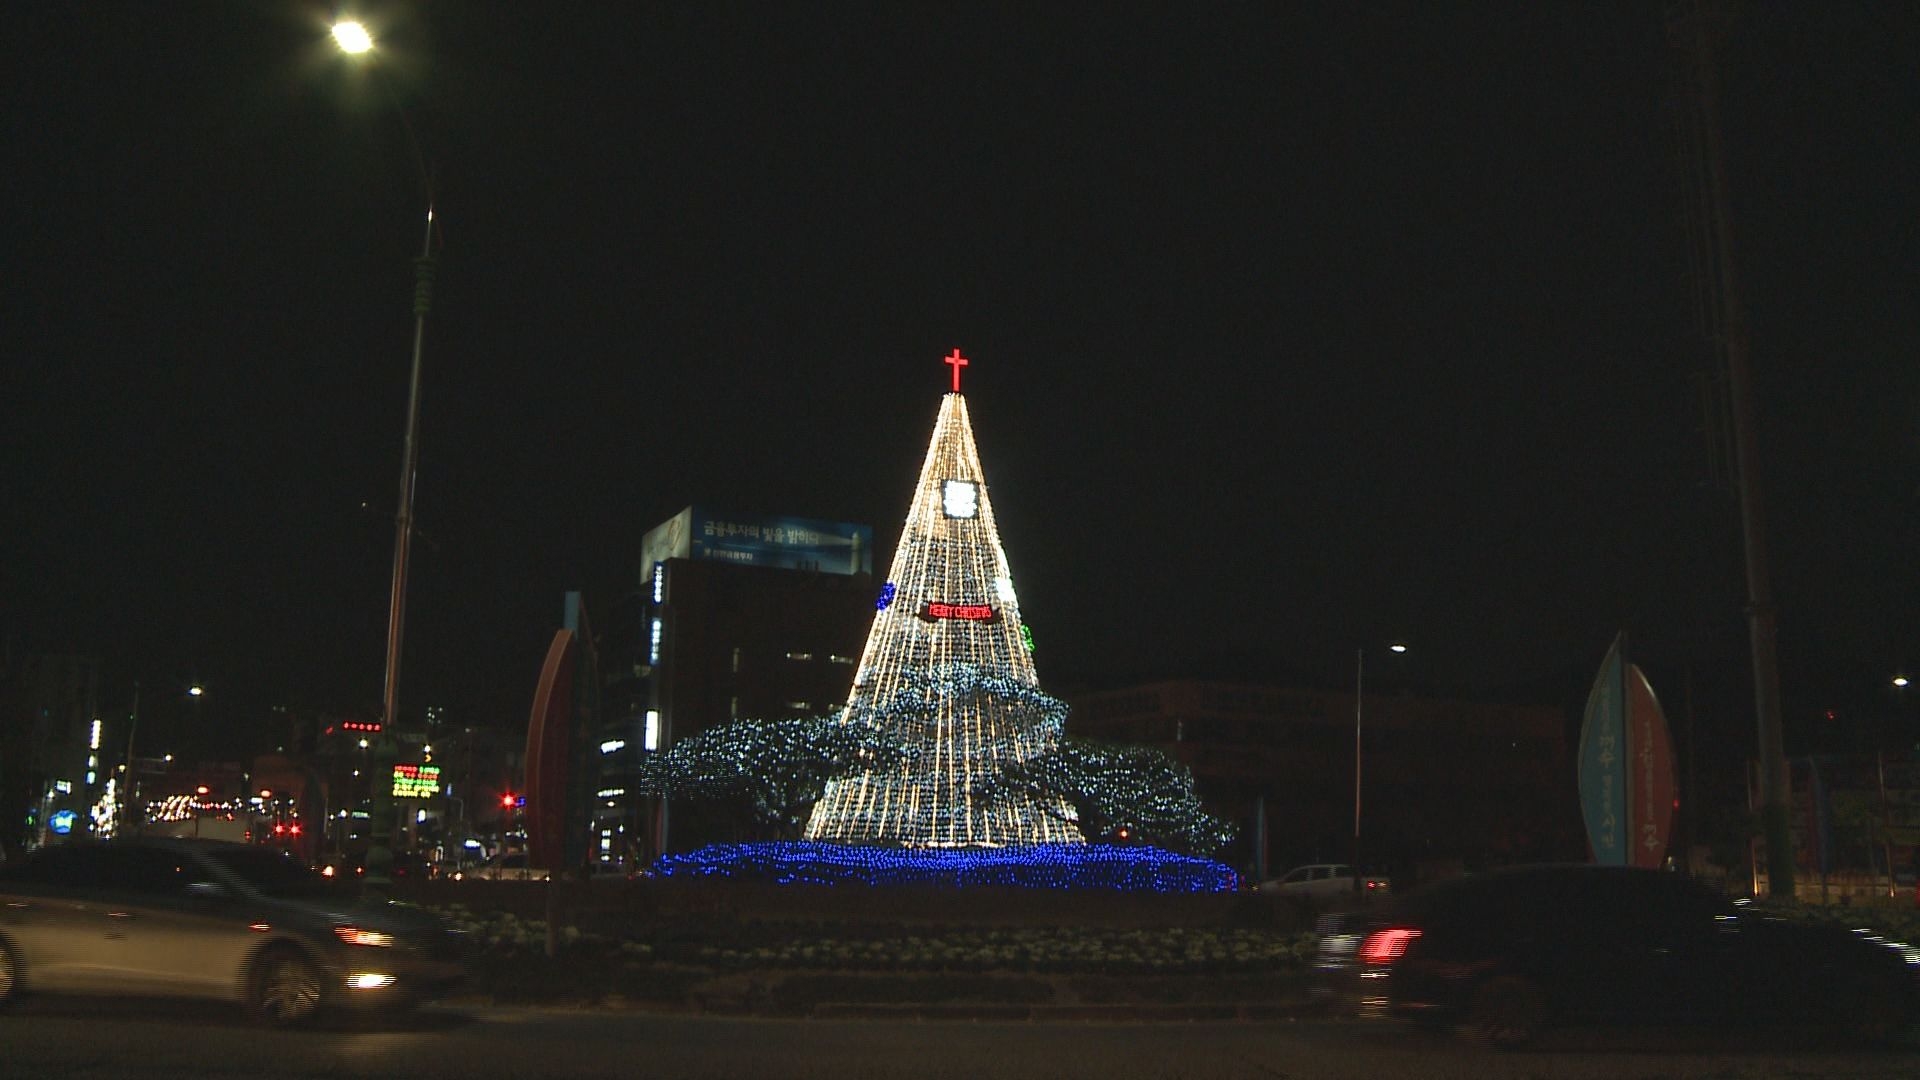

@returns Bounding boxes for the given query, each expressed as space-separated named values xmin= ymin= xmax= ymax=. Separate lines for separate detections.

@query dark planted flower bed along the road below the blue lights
xmin=440 ymin=905 xmax=1313 ymax=1013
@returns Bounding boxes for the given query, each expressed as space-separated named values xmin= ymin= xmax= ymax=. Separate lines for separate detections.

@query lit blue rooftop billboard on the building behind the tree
xmin=639 ymin=505 xmax=874 ymax=575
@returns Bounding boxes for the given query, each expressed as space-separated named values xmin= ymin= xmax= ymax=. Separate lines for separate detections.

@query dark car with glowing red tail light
xmin=1309 ymin=865 xmax=1920 ymax=1047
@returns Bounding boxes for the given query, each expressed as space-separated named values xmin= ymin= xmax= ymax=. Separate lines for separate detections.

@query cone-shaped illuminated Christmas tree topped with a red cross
xmin=806 ymin=350 xmax=1083 ymax=847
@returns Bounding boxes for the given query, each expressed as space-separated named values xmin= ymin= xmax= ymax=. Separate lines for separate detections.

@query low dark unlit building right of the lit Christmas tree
xmin=1068 ymin=680 xmax=1584 ymax=876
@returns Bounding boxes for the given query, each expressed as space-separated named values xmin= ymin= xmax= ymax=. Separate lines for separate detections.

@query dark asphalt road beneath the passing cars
xmin=0 ymin=999 xmax=1920 ymax=1080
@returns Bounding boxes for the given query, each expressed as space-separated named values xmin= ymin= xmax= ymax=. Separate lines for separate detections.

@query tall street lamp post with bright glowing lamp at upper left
xmin=332 ymin=21 xmax=434 ymax=886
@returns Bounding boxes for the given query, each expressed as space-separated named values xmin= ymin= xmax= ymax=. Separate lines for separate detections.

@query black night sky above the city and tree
xmin=0 ymin=0 xmax=1920 ymax=755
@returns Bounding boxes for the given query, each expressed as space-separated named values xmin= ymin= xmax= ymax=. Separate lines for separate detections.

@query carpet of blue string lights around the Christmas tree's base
xmin=653 ymin=842 xmax=1240 ymax=892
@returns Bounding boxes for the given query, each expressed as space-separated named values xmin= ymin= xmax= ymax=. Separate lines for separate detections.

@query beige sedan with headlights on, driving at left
xmin=0 ymin=838 xmax=468 ymax=1024
